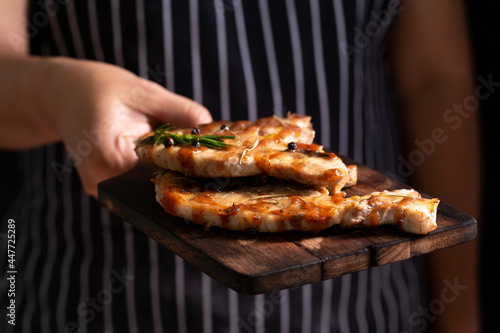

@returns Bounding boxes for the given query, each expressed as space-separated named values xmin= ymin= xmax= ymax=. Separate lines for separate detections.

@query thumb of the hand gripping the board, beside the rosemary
xmin=127 ymin=79 xmax=213 ymax=127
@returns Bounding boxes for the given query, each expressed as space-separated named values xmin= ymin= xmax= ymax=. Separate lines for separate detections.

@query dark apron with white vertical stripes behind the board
xmin=0 ymin=0 xmax=424 ymax=333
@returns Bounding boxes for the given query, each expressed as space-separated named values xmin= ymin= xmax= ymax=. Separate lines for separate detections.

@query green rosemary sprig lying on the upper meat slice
xmin=141 ymin=124 xmax=235 ymax=149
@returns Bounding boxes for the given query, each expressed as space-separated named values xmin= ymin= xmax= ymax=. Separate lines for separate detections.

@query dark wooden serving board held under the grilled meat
xmin=98 ymin=161 xmax=477 ymax=294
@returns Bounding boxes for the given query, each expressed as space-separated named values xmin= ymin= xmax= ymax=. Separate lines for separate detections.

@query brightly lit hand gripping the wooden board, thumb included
xmin=41 ymin=58 xmax=212 ymax=196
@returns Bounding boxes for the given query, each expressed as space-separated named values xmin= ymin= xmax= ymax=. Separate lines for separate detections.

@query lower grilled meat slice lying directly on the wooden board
xmin=153 ymin=171 xmax=439 ymax=234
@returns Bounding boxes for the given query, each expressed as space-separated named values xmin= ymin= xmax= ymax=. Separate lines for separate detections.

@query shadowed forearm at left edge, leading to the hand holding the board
xmin=0 ymin=53 xmax=59 ymax=149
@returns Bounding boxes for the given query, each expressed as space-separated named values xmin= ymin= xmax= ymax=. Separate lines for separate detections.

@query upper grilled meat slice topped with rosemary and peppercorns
xmin=136 ymin=114 xmax=356 ymax=193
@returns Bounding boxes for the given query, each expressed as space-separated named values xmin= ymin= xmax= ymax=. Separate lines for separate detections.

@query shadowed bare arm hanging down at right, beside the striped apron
xmin=389 ymin=0 xmax=486 ymax=333
